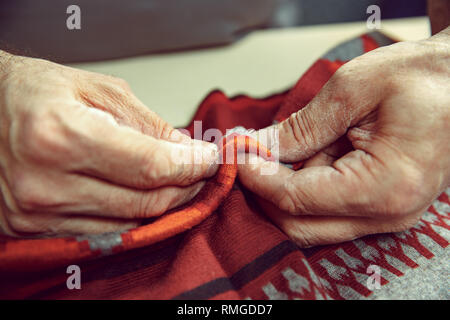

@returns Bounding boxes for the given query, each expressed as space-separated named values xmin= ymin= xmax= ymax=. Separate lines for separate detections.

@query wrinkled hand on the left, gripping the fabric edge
xmin=0 ymin=51 xmax=217 ymax=236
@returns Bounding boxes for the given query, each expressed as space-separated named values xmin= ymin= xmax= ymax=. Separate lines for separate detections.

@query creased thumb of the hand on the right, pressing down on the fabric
xmin=259 ymin=61 xmax=378 ymax=162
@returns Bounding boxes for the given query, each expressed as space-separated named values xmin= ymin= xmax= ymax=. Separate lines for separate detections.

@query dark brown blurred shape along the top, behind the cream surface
xmin=0 ymin=0 xmax=428 ymax=62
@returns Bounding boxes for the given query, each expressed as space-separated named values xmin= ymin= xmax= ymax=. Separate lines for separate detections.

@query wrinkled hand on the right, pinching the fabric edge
xmin=239 ymin=28 xmax=450 ymax=247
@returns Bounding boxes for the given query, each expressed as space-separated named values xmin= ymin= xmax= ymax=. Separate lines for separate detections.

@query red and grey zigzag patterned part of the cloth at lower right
xmin=251 ymin=188 xmax=450 ymax=299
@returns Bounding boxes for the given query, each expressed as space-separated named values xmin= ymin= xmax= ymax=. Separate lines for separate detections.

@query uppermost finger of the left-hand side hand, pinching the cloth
xmin=58 ymin=105 xmax=217 ymax=189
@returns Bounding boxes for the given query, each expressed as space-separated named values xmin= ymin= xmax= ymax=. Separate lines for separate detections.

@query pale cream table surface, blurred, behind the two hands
xmin=71 ymin=17 xmax=430 ymax=127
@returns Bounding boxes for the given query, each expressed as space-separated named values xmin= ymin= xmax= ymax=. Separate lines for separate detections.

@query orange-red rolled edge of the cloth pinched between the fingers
xmin=0 ymin=134 xmax=271 ymax=273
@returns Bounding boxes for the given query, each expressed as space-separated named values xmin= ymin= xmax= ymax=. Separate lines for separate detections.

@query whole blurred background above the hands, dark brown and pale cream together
xmin=0 ymin=0 xmax=432 ymax=126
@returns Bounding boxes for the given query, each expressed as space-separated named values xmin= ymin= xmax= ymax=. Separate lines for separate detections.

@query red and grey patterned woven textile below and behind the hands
xmin=0 ymin=33 xmax=450 ymax=299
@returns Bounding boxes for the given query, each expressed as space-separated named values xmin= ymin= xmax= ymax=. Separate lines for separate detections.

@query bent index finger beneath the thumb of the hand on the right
xmin=239 ymin=150 xmax=389 ymax=216
